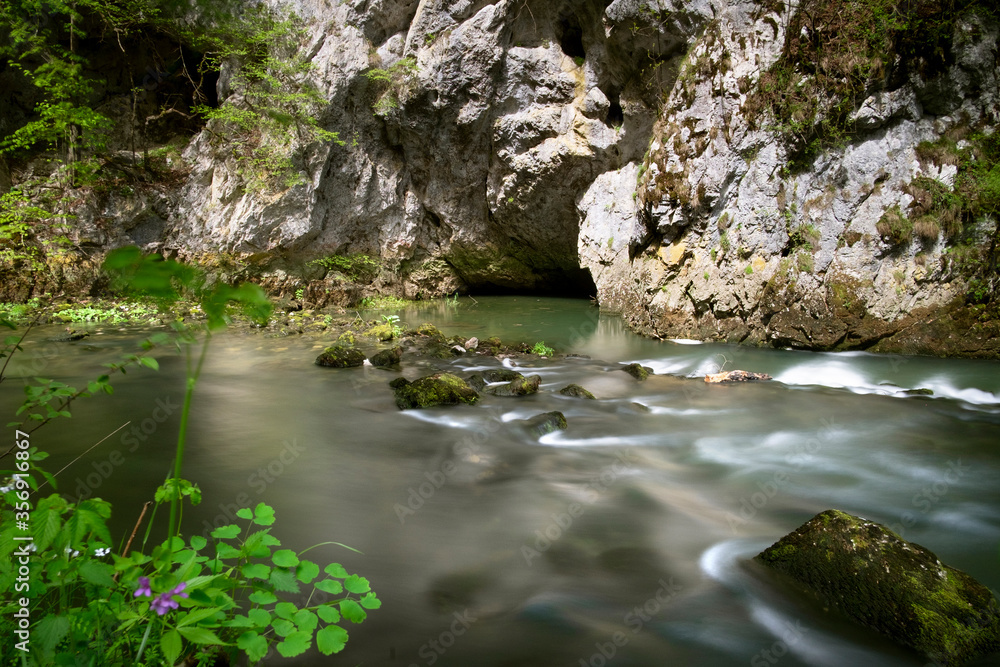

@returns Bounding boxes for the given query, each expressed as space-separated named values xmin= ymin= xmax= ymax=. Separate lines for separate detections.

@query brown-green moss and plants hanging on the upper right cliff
xmin=744 ymin=0 xmax=996 ymax=171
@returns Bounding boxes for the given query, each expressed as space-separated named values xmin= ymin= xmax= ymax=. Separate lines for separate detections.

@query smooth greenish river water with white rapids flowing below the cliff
xmin=2 ymin=297 xmax=1000 ymax=667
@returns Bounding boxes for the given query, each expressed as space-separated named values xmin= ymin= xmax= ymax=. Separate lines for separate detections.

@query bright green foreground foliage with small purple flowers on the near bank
xmin=0 ymin=248 xmax=381 ymax=667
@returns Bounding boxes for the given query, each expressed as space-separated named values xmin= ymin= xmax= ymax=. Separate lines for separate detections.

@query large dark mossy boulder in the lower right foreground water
xmin=754 ymin=510 xmax=1000 ymax=665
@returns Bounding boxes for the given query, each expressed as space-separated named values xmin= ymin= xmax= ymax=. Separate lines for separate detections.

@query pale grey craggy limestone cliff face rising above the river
xmin=48 ymin=0 xmax=1000 ymax=356
